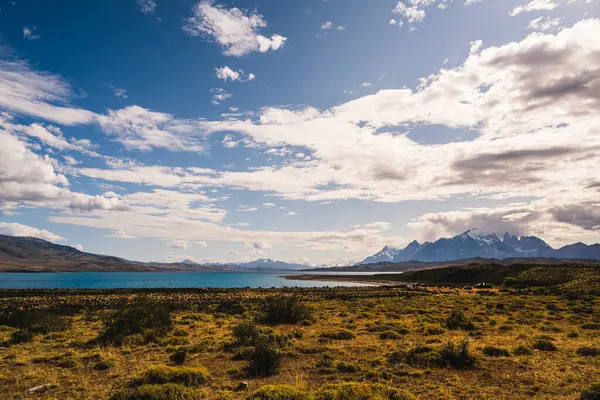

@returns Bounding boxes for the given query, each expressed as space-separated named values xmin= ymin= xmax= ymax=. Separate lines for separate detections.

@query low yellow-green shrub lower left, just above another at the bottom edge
xmin=130 ymin=365 xmax=211 ymax=386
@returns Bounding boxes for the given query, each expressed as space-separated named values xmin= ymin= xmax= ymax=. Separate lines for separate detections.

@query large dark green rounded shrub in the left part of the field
xmin=98 ymin=301 xmax=173 ymax=345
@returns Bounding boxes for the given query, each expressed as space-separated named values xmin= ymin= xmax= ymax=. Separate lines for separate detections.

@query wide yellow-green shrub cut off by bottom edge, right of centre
xmin=314 ymin=382 xmax=416 ymax=400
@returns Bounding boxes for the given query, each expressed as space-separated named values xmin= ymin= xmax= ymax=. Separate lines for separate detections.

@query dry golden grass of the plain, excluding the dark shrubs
xmin=0 ymin=288 xmax=600 ymax=399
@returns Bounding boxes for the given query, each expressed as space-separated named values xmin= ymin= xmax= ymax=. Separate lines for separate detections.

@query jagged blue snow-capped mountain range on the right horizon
xmin=355 ymin=229 xmax=600 ymax=265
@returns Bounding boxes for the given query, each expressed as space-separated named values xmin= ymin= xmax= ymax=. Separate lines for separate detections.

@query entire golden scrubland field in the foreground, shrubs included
xmin=0 ymin=287 xmax=600 ymax=400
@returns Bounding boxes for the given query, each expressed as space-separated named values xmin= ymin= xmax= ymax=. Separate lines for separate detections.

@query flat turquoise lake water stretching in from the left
xmin=0 ymin=272 xmax=370 ymax=289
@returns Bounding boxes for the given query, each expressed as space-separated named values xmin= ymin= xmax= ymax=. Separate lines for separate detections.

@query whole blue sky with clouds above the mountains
xmin=0 ymin=0 xmax=600 ymax=265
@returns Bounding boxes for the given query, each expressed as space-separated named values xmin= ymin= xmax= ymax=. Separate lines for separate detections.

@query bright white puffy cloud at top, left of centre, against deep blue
xmin=183 ymin=0 xmax=287 ymax=57
